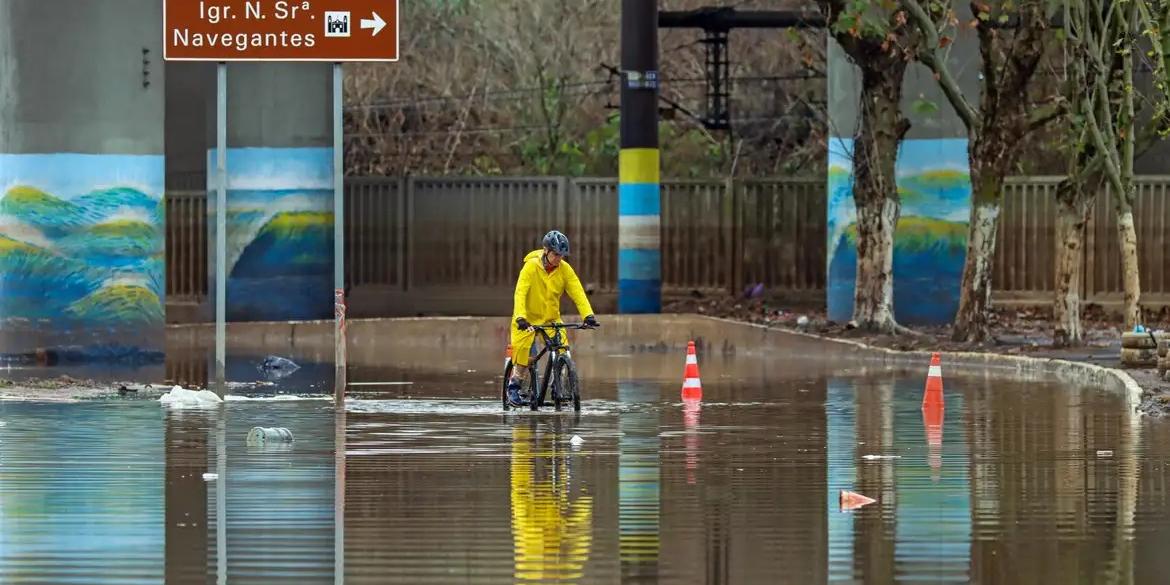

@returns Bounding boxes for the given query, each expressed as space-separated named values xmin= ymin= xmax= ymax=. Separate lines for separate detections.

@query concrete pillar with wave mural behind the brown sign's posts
xmin=207 ymin=62 xmax=333 ymax=321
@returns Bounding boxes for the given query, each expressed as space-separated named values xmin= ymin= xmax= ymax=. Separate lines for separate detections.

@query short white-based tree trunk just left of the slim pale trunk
xmin=1052 ymin=179 xmax=1093 ymax=347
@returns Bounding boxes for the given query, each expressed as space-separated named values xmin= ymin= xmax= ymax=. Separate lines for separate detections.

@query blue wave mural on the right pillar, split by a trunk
xmin=827 ymin=138 xmax=971 ymax=325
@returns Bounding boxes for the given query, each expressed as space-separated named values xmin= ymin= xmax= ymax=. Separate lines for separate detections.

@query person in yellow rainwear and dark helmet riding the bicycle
xmin=508 ymin=229 xmax=600 ymax=406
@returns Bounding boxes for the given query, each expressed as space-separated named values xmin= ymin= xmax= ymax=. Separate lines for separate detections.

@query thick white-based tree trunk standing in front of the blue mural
xmin=853 ymin=60 xmax=909 ymax=333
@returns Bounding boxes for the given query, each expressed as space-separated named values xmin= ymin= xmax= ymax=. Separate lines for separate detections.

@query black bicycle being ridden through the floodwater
xmin=500 ymin=323 xmax=593 ymax=411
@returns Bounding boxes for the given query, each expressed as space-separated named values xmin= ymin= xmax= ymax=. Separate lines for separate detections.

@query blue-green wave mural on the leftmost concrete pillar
xmin=0 ymin=153 xmax=166 ymax=362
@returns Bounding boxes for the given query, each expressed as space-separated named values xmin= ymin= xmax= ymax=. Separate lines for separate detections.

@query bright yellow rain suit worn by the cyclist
xmin=511 ymin=248 xmax=593 ymax=367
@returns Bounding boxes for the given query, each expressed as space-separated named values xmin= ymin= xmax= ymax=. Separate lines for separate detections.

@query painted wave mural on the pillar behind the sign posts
xmin=207 ymin=147 xmax=333 ymax=321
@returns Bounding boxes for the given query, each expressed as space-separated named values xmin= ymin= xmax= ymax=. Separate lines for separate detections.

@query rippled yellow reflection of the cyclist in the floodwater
xmin=511 ymin=420 xmax=593 ymax=581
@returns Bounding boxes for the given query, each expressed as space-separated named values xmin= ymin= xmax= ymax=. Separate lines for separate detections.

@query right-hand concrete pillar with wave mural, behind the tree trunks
xmin=826 ymin=2 xmax=979 ymax=324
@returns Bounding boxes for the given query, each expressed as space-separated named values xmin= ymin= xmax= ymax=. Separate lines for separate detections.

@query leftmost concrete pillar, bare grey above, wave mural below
xmin=0 ymin=0 xmax=165 ymax=362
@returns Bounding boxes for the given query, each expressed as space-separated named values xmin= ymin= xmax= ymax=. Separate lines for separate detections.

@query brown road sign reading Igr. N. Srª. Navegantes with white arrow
xmin=163 ymin=0 xmax=399 ymax=61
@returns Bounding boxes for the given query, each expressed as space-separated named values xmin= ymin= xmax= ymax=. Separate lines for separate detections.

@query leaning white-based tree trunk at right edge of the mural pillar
xmin=952 ymin=139 xmax=1007 ymax=342
